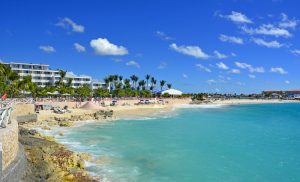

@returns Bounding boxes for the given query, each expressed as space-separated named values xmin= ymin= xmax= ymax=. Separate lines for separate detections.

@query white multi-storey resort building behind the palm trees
xmin=2 ymin=62 xmax=105 ymax=89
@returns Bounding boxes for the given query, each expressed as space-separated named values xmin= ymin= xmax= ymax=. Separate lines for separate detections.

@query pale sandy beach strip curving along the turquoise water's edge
xmin=17 ymin=100 xmax=299 ymax=179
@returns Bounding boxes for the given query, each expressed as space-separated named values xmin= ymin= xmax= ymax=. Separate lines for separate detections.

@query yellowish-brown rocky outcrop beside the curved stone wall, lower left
xmin=19 ymin=128 xmax=97 ymax=182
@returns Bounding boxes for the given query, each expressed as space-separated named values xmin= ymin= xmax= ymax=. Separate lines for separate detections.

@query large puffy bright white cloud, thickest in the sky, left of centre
xmin=90 ymin=38 xmax=128 ymax=56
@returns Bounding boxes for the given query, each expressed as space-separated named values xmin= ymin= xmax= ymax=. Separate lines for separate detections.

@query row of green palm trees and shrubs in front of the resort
xmin=0 ymin=63 xmax=172 ymax=97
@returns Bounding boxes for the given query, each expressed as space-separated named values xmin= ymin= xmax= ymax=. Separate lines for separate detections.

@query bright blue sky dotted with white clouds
xmin=0 ymin=0 xmax=300 ymax=93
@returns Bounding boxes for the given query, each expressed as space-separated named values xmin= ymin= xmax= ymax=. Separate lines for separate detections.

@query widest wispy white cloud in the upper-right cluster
xmin=241 ymin=24 xmax=292 ymax=38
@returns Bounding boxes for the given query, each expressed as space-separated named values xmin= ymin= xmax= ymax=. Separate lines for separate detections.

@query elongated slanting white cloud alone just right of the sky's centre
xmin=170 ymin=43 xmax=209 ymax=59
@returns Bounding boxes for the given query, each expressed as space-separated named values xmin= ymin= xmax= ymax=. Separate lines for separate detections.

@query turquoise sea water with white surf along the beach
xmin=54 ymin=104 xmax=300 ymax=182
